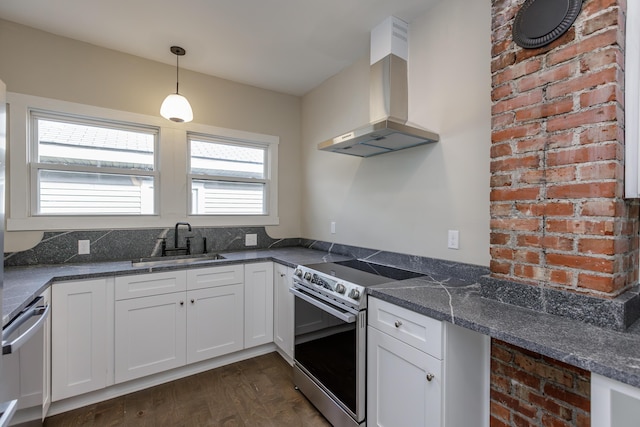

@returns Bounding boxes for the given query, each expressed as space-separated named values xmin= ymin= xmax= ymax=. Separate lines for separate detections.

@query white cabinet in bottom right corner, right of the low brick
xmin=591 ymin=373 xmax=640 ymax=427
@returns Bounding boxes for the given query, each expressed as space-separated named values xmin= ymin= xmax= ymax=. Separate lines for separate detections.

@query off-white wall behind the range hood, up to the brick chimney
xmin=302 ymin=0 xmax=491 ymax=265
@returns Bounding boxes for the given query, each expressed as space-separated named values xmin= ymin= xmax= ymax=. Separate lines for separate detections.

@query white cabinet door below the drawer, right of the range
xmin=367 ymin=326 xmax=442 ymax=427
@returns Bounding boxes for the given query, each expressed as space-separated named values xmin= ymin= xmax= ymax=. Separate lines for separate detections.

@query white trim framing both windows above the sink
xmin=6 ymin=92 xmax=279 ymax=231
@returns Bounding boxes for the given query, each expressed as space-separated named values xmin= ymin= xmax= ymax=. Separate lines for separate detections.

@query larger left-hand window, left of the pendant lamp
xmin=31 ymin=110 xmax=158 ymax=215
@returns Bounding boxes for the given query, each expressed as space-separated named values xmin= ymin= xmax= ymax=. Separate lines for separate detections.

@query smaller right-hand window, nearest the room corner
xmin=188 ymin=134 xmax=270 ymax=215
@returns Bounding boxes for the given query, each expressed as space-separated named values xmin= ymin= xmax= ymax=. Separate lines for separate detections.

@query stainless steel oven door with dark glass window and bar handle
xmin=291 ymin=284 xmax=366 ymax=425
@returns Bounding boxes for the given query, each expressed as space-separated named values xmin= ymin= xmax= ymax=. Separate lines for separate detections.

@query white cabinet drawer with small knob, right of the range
xmin=368 ymin=297 xmax=442 ymax=359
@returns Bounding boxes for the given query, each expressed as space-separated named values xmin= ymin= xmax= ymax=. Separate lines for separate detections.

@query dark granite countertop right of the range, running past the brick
xmin=368 ymin=276 xmax=640 ymax=387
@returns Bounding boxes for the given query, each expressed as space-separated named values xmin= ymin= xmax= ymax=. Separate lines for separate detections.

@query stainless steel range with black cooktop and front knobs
xmin=290 ymin=260 xmax=421 ymax=427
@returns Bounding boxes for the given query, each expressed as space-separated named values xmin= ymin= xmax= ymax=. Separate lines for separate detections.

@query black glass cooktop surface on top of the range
xmin=306 ymin=259 xmax=424 ymax=287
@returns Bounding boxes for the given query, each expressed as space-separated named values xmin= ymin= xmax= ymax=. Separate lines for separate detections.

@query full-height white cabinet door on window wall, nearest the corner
xmin=244 ymin=262 xmax=273 ymax=348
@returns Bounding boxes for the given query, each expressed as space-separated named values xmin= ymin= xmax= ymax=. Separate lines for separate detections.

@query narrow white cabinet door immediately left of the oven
xmin=273 ymin=263 xmax=293 ymax=362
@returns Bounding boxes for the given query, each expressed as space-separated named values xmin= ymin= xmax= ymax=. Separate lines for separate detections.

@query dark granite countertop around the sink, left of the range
xmin=2 ymin=247 xmax=351 ymax=326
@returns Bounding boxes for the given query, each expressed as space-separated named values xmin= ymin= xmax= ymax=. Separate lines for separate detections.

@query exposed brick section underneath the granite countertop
xmin=491 ymin=339 xmax=596 ymax=427
